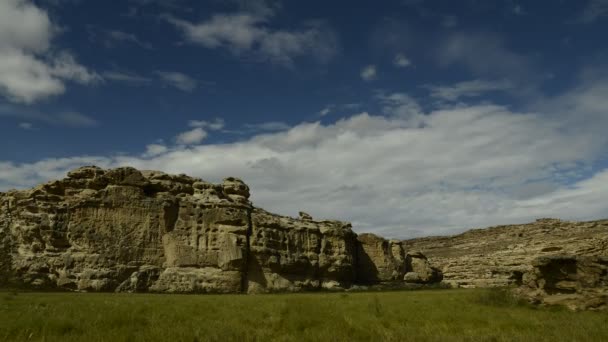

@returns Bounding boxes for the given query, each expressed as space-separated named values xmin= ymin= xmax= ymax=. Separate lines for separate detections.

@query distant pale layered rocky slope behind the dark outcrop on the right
xmin=403 ymin=219 xmax=608 ymax=287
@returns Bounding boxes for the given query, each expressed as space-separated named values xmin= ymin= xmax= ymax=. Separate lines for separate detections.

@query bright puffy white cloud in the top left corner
xmin=0 ymin=0 xmax=100 ymax=103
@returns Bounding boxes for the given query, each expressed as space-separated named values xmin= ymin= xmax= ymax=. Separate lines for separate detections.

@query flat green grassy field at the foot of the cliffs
xmin=0 ymin=290 xmax=608 ymax=341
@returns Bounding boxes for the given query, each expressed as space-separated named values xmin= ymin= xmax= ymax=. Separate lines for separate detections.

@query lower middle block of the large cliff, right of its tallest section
xmin=248 ymin=209 xmax=356 ymax=292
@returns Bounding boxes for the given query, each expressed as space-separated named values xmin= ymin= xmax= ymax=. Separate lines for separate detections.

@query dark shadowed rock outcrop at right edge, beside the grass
xmin=515 ymin=255 xmax=608 ymax=310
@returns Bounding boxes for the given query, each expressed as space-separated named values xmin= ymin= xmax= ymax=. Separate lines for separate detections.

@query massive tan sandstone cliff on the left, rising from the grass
xmin=0 ymin=166 xmax=441 ymax=293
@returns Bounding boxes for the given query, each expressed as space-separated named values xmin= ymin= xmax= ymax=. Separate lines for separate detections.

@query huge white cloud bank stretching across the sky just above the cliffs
xmin=0 ymin=79 xmax=608 ymax=238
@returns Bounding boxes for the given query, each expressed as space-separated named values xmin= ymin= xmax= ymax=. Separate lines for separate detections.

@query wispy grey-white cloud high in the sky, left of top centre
xmin=165 ymin=6 xmax=338 ymax=66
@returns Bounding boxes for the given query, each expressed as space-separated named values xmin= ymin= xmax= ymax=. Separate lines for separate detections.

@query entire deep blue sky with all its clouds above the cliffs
xmin=0 ymin=0 xmax=608 ymax=237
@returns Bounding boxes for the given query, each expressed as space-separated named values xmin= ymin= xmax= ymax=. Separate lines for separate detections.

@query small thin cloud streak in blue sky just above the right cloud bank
xmin=426 ymin=79 xmax=513 ymax=101
